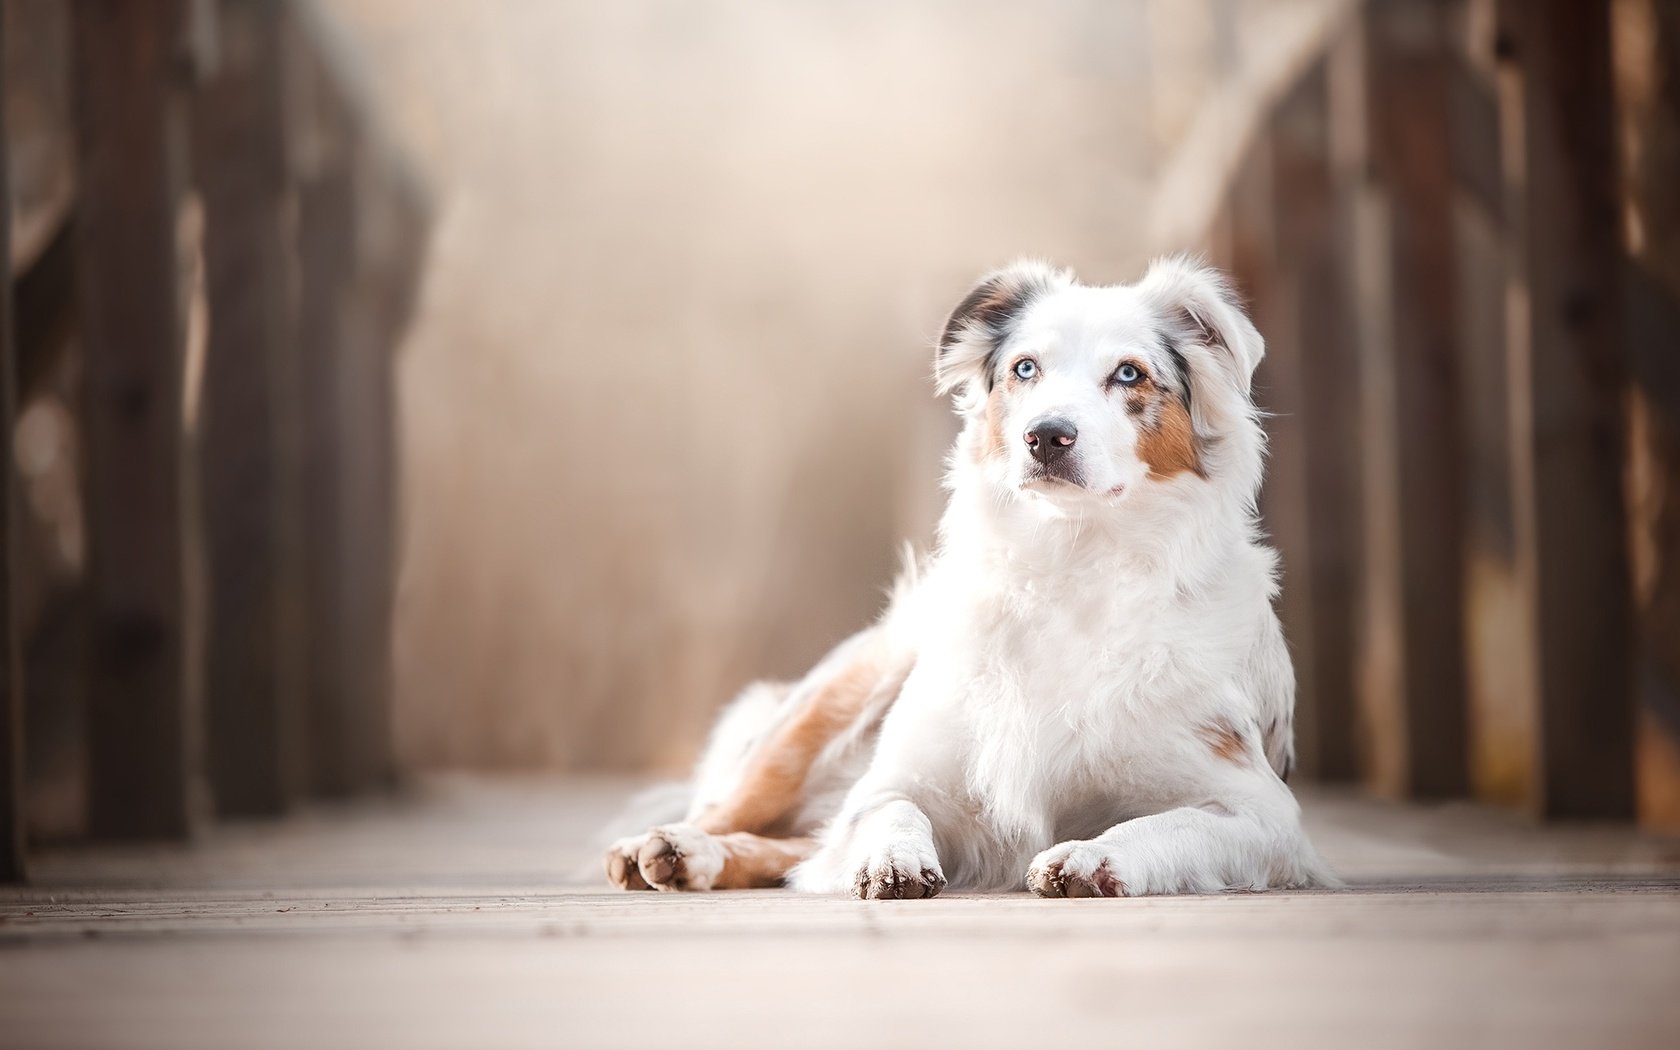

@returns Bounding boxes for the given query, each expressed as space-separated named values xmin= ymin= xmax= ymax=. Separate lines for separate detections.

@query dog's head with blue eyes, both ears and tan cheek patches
xmin=936 ymin=259 xmax=1263 ymax=502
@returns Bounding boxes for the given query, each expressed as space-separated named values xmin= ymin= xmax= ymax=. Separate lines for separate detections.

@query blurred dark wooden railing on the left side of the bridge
xmin=0 ymin=0 xmax=427 ymax=879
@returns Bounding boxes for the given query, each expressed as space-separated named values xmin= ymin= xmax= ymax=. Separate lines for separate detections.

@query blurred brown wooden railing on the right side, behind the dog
xmin=1206 ymin=0 xmax=1680 ymax=827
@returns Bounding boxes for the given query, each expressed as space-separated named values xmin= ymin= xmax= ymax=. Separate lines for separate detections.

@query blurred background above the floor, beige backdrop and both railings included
xmin=0 ymin=0 xmax=1680 ymax=872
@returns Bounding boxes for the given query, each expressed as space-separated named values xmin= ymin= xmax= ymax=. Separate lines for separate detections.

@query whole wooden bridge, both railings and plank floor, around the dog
xmin=0 ymin=0 xmax=1680 ymax=1048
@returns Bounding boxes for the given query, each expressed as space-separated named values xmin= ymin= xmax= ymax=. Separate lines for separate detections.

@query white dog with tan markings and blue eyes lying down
xmin=606 ymin=257 xmax=1337 ymax=899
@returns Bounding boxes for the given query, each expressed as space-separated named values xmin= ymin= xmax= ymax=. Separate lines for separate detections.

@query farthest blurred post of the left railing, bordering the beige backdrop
xmin=291 ymin=18 xmax=425 ymax=795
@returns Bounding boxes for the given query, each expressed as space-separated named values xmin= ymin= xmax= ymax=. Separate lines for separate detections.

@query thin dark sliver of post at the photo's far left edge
xmin=0 ymin=8 xmax=25 ymax=882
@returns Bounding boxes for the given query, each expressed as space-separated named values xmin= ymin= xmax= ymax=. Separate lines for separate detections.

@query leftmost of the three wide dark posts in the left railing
xmin=72 ymin=0 xmax=197 ymax=838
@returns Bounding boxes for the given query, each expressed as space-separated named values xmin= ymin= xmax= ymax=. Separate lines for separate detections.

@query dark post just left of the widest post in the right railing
xmin=1356 ymin=0 xmax=1467 ymax=798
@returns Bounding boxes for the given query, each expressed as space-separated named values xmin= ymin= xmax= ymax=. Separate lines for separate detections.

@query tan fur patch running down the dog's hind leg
xmin=694 ymin=643 xmax=914 ymax=835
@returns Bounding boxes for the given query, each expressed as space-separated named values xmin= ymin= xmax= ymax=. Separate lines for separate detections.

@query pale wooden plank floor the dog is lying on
xmin=0 ymin=780 xmax=1680 ymax=1050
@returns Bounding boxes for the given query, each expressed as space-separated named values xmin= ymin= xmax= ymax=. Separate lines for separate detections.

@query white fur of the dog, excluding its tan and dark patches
xmin=635 ymin=259 xmax=1336 ymax=894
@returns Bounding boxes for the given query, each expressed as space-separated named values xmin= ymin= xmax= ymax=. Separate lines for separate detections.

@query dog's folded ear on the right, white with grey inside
xmin=1137 ymin=255 xmax=1265 ymax=418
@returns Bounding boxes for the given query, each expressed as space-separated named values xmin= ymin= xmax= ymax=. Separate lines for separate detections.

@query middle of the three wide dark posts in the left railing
xmin=193 ymin=0 xmax=304 ymax=815
